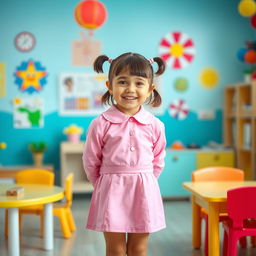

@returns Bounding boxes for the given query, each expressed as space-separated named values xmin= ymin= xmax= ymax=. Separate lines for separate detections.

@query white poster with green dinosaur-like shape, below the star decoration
xmin=13 ymin=98 xmax=44 ymax=128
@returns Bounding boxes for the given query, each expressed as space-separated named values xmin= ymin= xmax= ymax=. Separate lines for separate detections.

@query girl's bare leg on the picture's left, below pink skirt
xmin=104 ymin=232 xmax=126 ymax=256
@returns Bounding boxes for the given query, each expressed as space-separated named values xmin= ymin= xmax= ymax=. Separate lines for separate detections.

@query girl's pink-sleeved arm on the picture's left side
xmin=83 ymin=119 xmax=103 ymax=186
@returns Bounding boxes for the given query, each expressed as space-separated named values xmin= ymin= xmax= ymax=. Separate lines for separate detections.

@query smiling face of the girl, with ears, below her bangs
xmin=106 ymin=71 xmax=156 ymax=116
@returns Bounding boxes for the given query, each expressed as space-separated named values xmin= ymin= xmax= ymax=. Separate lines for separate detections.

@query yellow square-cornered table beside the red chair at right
xmin=183 ymin=181 xmax=256 ymax=256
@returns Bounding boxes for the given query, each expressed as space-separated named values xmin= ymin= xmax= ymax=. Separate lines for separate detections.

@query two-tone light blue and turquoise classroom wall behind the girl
xmin=0 ymin=0 xmax=253 ymax=180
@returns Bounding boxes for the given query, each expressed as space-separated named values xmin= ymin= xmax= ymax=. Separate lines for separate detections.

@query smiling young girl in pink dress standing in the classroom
xmin=83 ymin=53 xmax=166 ymax=256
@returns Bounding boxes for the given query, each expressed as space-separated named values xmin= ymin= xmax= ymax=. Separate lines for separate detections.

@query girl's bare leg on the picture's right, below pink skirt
xmin=127 ymin=233 xmax=149 ymax=256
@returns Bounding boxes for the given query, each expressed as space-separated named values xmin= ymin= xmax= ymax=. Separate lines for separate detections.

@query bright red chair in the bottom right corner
xmin=223 ymin=186 xmax=256 ymax=256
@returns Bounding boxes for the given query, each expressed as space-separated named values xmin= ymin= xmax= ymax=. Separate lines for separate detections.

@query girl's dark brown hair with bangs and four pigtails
xmin=93 ymin=52 xmax=165 ymax=107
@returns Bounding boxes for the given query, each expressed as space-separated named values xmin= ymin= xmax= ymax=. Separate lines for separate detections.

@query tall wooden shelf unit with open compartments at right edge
xmin=223 ymin=82 xmax=256 ymax=180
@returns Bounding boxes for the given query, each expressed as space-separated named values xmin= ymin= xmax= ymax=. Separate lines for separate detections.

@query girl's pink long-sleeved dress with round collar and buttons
xmin=83 ymin=106 xmax=166 ymax=233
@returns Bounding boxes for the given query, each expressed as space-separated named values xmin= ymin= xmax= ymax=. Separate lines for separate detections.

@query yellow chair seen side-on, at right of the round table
xmin=40 ymin=173 xmax=76 ymax=238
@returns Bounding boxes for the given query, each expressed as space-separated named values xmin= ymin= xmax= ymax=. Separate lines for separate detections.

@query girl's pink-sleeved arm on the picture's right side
xmin=153 ymin=121 xmax=166 ymax=178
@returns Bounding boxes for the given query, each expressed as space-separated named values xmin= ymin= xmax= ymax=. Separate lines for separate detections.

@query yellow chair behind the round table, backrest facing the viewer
xmin=5 ymin=169 xmax=54 ymax=237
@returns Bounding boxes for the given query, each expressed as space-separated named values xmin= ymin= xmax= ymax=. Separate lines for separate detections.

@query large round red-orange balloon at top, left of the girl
xmin=74 ymin=0 xmax=107 ymax=29
